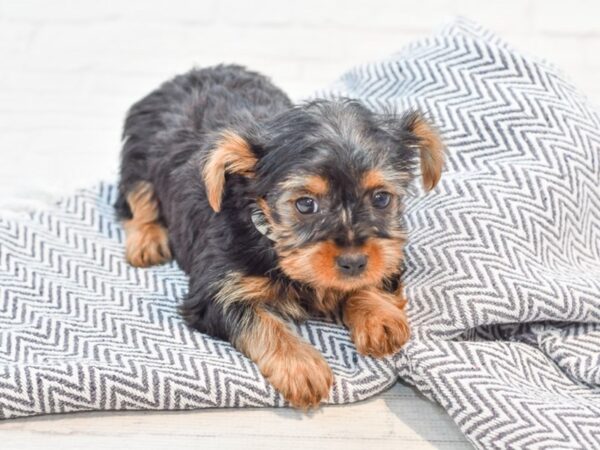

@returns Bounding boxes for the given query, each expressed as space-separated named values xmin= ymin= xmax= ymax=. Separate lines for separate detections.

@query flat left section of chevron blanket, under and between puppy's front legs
xmin=0 ymin=184 xmax=397 ymax=418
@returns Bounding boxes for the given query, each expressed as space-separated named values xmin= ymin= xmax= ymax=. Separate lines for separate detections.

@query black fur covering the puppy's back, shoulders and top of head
xmin=116 ymin=66 xmax=417 ymax=339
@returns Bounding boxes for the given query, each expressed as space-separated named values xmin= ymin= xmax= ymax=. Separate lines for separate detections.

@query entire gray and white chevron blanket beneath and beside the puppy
xmin=0 ymin=20 xmax=600 ymax=449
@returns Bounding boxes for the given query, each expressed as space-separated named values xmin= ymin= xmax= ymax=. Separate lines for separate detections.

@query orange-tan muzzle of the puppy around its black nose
xmin=279 ymin=238 xmax=403 ymax=292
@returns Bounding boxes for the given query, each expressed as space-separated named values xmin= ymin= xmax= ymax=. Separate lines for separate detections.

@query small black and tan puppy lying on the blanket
xmin=116 ymin=66 xmax=443 ymax=408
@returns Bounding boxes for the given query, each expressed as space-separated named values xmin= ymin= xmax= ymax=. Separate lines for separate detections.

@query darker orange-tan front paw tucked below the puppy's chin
xmin=352 ymin=309 xmax=410 ymax=358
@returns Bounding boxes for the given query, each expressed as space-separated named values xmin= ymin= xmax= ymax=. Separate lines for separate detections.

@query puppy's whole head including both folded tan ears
xmin=204 ymin=100 xmax=443 ymax=291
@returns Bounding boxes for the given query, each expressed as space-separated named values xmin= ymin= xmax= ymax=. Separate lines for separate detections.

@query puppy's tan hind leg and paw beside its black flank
xmin=123 ymin=181 xmax=171 ymax=267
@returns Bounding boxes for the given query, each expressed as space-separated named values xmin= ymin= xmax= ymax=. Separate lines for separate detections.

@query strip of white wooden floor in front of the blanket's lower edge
xmin=0 ymin=384 xmax=471 ymax=450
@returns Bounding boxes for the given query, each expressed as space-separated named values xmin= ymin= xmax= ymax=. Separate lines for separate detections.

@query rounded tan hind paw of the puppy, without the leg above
xmin=125 ymin=223 xmax=171 ymax=267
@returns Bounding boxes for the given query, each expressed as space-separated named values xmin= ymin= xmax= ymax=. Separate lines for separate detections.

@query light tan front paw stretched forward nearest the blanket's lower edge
xmin=263 ymin=344 xmax=333 ymax=410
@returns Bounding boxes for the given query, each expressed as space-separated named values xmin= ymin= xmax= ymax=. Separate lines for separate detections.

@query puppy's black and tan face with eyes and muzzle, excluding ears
xmin=259 ymin=169 xmax=405 ymax=291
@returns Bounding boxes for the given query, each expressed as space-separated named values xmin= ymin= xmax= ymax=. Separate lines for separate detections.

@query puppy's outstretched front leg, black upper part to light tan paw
xmin=181 ymin=272 xmax=333 ymax=409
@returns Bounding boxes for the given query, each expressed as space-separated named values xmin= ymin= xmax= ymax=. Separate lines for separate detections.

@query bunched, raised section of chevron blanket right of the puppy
xmin=326 ymin=20 xmax=600 ymax=449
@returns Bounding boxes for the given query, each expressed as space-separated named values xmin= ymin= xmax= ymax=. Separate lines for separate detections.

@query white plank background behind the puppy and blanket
xmin=0 ymin=0 xmax=600 ymax=204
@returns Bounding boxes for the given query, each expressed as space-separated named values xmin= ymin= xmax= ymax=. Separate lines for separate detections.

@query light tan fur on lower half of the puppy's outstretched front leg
xmin=235 ymin=308 xmax=333 ymax=409
